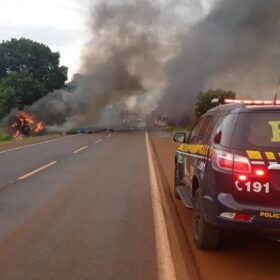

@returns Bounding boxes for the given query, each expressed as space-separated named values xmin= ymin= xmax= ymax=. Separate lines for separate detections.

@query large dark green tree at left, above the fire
xmin=0 ymin=38 xmax=67 ymax=119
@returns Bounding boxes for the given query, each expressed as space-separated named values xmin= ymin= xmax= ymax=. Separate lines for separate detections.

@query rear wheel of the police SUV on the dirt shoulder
xmin=193 ymin=188 xmax=222 ymax=250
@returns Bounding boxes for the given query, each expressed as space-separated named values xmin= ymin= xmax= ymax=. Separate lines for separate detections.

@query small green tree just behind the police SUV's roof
xmin=195 ymin=89 xmax=236 ymax=117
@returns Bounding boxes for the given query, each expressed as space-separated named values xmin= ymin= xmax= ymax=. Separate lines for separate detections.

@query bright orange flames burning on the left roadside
xmin=9 ymin=111 xmax=45 ymax=137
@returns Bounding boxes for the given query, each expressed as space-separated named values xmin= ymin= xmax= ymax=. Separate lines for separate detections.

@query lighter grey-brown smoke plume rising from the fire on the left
xmin=26 ymin=0 xmax=202 ymax=127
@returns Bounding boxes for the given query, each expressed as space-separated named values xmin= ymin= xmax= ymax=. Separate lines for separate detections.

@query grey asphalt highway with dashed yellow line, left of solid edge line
xmin=0 ymin=132 xmax=159 ymax=280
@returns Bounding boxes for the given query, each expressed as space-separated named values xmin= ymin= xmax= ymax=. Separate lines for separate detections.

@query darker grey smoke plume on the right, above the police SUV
xmin=159 ymin=0 xmax=280 ymax=120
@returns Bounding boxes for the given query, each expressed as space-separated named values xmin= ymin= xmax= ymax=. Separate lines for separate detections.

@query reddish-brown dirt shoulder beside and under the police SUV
xmin=152 ymin=132 xmax=280 ymax=280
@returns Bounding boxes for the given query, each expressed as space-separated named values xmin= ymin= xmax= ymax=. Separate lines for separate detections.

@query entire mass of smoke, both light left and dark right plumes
xmin=26 ymin=0 xmax=280 ymax=126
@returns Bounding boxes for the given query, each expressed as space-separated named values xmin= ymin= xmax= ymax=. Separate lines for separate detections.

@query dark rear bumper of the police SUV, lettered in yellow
xmin=204 ymin=193 xmax=280 ymax=234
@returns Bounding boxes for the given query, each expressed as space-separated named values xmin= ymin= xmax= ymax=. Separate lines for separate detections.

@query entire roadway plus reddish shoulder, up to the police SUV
xmin=0 ymin=132 xmax=280 ymax=280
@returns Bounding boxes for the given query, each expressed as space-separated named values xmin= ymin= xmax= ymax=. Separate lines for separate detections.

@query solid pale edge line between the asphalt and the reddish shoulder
xmin=146 ymin=133 xmax=176 ymax=280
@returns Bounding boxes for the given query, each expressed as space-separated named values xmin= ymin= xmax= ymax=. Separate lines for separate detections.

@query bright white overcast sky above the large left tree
xmin=0 ymin=0 xmax=213 ymax=78
